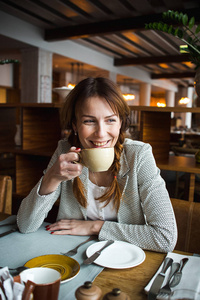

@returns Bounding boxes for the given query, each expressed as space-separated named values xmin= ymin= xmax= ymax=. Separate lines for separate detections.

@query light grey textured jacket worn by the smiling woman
xmin=17 ymin=139 xmax=177 ymax=252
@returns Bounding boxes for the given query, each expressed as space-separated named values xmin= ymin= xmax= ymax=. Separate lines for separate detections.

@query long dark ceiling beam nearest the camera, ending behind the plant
xmin=44 ymin=9 xmax=200 ymax=42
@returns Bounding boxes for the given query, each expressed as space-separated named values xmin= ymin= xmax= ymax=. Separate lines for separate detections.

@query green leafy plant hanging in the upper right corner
xmin=145 ymin=10 xmax=200 ymax=68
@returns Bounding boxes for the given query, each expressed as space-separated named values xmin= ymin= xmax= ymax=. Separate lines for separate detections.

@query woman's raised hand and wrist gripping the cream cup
xmin=39 ymin=147 xmax=83 ymax=195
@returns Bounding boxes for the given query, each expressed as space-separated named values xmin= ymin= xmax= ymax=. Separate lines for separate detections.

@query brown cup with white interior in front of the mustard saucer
xmin=19 ymin=268 xmax=61 ymax=300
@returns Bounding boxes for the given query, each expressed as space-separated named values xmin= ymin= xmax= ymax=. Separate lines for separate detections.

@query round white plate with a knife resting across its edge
xmin=86 ymin=241 xmax=146 ymax=269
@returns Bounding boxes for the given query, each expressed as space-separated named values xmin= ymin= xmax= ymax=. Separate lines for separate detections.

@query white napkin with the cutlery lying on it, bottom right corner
xmin=144 ymin=252 xmax=200 ymax=300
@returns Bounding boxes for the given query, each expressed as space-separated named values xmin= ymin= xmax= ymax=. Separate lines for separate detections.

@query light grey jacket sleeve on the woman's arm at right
xmin=99 ymin=144 xmax=177 ymax=252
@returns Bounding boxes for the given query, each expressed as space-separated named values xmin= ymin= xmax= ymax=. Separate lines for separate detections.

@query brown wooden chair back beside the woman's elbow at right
xmin=171 ymin=199 xmax=200 ymax=254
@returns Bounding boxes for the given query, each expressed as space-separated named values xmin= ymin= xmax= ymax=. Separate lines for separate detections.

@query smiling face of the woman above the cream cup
xmin=74 ymin=96 xmax=121 ymax=148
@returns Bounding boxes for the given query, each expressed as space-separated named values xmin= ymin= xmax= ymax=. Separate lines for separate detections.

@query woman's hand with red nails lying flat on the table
xmin=46 ymin=219 xmax=104 ymax=235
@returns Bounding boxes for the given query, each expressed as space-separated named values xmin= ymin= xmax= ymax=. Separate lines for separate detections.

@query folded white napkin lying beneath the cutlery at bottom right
xmin=144 ymin=252 xmax=200 ymax=300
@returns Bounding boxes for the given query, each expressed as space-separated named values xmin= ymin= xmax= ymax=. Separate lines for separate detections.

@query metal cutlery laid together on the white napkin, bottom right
xmin=148 ymin=257 xmax=188 ymax=300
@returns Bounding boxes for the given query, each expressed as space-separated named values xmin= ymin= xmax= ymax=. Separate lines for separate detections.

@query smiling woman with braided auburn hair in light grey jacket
xmin=17 ymin=77 xmax=177 ymax=252
